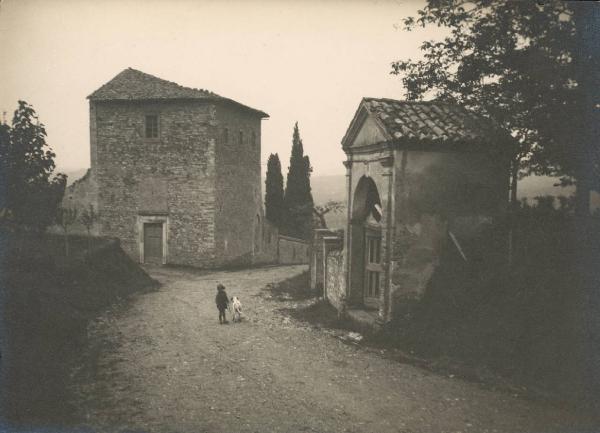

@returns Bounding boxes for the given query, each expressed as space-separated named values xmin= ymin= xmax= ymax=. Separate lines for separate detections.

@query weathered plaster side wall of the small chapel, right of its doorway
xmin=388 ymin=150 xmax=508 ymax=314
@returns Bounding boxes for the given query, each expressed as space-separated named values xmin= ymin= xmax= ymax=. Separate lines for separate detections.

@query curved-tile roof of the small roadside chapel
xmin=343 ymin=98 xmax=506 ymax=147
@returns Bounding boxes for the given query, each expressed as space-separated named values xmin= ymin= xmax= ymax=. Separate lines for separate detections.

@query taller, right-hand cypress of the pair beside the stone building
xmin=284 ymin=122 xmax=314 ymax=239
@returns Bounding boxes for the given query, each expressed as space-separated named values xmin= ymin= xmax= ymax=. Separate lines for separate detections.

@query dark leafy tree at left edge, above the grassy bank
xmin=0 ymin=101 xmax=66 ymax=232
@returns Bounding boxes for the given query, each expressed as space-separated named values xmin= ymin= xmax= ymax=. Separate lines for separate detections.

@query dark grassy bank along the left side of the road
xmin=0 ymin=232 xmax=156 ymax=425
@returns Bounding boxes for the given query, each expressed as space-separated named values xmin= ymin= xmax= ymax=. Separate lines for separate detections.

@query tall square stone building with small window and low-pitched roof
xmin=88 ymin=68 xmax=268 ymax=267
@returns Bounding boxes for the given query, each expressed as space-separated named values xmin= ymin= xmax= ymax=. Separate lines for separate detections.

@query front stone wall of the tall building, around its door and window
xmin=90 ymin=101 xmax=216 ymax=267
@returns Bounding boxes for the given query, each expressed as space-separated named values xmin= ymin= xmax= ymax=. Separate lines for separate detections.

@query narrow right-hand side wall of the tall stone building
xmin=215 ymin=104 xmax=269 ymax=265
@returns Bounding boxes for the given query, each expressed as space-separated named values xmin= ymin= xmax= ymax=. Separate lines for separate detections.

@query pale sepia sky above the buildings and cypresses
xmin=0 ymin=0 xmax=439 ymax=176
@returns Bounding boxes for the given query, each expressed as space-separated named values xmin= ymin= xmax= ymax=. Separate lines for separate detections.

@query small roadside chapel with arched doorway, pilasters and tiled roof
xmin=311 ymin=98 xmax=512 ymax=323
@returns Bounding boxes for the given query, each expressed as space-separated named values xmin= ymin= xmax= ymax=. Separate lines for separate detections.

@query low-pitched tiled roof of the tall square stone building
xmin=88 ymin=68 xmax=268 ymax=117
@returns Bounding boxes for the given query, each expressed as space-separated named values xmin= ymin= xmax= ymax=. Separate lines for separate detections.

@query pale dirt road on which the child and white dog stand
xmin=72 ymin=266 xmax=594 ymax=433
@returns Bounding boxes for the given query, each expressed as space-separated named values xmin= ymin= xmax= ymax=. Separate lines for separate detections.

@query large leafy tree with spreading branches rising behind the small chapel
xmin=392 ymin=0 xmax=600 ymax=216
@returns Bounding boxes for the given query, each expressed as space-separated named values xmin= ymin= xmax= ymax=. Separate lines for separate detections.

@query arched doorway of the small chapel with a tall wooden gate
xmin=349 ymin=176 xmax=383 ymax=309
